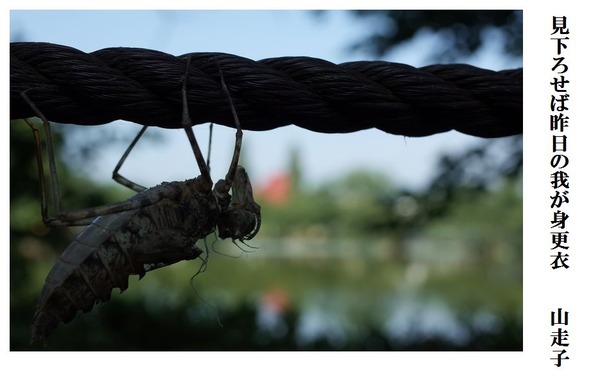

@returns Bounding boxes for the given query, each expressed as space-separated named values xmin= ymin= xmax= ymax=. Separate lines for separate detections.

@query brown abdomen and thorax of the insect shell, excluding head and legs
xmin=32 ymin=177 xmax=219 ymax=342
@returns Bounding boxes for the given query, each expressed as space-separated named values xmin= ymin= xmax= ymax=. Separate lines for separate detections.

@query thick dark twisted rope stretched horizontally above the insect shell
xmin=10 ymin=42 xmax=523 ymax=138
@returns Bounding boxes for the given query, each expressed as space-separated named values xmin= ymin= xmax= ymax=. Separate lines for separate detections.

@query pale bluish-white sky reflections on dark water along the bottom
xmin=248 ymin=291 xmax=510 ymax=349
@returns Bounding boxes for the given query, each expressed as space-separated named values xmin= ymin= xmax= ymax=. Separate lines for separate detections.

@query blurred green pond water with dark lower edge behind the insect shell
xmin=15 ymin=232 xmax=522 ymax=350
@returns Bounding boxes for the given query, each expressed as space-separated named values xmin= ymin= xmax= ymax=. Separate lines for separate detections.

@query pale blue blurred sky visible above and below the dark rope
xmin=10 ymin=10 xmax=522 ymax=189
